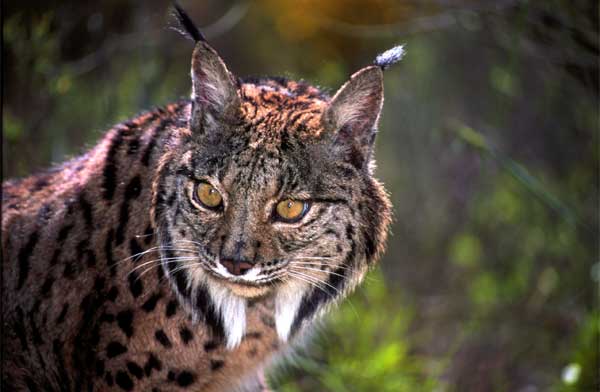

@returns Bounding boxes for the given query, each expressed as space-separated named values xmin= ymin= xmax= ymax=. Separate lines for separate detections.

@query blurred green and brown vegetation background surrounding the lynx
xmin=2 ymin=0 xmax=600 ymax=392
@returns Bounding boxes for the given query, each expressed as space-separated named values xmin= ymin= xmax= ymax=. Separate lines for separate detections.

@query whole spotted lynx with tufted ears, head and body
xmin=2 ymin=5 xmax=402 ymax=391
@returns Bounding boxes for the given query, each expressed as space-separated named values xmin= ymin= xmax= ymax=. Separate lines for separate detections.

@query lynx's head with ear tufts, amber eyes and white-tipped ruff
xmin=152 ymin=5 xmax=401 ymax=348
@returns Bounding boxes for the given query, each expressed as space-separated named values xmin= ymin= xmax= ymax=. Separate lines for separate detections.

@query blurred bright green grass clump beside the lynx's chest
xmin=271 ymin=270 xmax=439 ymax=392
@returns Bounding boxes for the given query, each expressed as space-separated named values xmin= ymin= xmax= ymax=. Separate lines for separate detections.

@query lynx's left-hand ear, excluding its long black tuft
xmin=191 ymin=41 xmax=241 ymax=133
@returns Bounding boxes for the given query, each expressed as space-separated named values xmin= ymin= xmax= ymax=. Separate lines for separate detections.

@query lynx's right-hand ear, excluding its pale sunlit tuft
xmin=323 ymin=65 xmax=383 ymax=168
